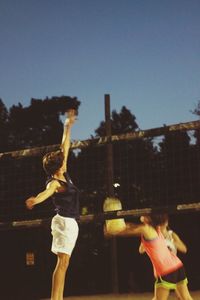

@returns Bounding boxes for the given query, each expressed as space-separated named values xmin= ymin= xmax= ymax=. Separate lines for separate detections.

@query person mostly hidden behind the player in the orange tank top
xmin=139 ymin=214 xmax=187 ymax=300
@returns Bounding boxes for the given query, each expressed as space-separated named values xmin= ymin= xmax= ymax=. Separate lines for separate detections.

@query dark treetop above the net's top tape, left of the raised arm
xmin=0 ymin=96 xmax=80 ymax=151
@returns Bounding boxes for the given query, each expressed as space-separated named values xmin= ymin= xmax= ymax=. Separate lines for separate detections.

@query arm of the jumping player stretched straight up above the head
xmin=61 ymin=109 xmax=76 ymax=172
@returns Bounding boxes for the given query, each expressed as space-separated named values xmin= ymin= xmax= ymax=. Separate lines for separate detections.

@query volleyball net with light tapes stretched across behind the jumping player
xmin=0 ymin=121 xmax=200 ymax=228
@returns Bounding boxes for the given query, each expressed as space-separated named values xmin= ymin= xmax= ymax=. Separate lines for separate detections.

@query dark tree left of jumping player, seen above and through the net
xmin=0 ymin=96 xmax=80 ymax=219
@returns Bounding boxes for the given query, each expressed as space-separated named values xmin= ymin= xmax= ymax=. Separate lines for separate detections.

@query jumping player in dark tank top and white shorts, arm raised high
xmin=26 ymin=109 xmax=79 ymax=300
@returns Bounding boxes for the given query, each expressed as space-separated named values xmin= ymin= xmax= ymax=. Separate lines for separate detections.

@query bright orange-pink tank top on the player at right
xmin=141 ymin=230 xmax=183 ymax=277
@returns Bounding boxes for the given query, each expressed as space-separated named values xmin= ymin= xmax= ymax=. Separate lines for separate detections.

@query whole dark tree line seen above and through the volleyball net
xmin=0 ymin=96 xmax=200 ymax=219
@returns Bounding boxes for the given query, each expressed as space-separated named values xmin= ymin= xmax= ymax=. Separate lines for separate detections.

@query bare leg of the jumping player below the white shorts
xmin=51 ymin=253 xmax=70 ymax=300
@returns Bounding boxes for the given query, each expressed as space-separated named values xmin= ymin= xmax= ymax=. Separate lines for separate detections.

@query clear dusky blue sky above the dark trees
xmin=0 ymin=0 xmax=200 ymax=139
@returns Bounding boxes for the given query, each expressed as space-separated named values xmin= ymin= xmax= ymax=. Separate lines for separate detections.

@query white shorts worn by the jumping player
xmin=51 ymin=214 xmax=79 ymax=255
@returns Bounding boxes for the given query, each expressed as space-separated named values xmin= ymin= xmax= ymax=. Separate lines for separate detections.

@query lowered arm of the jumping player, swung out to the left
xmin=25 ymin=180 xmax=59 ymax=209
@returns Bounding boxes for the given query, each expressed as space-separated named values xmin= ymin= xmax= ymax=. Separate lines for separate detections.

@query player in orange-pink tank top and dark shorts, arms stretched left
xmin=104 ymin=213 xmax=192 ymax=300
